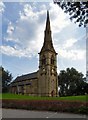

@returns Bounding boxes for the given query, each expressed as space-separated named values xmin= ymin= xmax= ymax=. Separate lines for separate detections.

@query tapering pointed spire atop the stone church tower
xmin=40 ymin=11 xmax=56 ymax=53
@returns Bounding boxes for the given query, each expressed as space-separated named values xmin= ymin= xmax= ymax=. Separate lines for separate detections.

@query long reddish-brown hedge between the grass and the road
xmin=2 ymin=99 xmax=88 ymax=114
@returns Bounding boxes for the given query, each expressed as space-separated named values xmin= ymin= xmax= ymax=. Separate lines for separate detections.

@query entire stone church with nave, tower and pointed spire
xmin=10 ymin=11 xmax=58 ymax=97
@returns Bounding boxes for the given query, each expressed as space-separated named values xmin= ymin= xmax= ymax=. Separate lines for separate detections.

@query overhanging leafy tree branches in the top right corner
xmin=54 ymin=0 xmax=88 ymax=27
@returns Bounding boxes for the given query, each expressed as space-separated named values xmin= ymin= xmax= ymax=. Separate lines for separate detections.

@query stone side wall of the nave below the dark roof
xmin=10 ymin=79 xmax=38 ymax=95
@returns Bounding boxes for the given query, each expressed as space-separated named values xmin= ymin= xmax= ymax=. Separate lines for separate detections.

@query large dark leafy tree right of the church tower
xmin=58 ymin=68 xmax=88 ymax=96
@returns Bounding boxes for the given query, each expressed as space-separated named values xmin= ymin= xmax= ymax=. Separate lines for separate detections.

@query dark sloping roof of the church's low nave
xmin=12 ymin=72 xmax=38 ymax=83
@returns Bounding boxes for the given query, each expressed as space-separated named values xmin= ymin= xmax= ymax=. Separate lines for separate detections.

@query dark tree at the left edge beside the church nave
xmin=0 ymin=67 xmax=12 ymax=92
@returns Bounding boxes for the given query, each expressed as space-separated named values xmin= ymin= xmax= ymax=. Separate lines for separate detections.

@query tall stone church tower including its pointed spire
xmin=38 ymin=11 xmax=58 ymax=96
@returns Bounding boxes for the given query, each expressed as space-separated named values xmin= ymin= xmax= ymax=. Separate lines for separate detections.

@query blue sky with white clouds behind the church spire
xmin=0 ymin=2 xmax=86 ymax=79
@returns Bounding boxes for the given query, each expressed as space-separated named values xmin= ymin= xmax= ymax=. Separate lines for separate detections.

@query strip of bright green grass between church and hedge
xmin=0 ymin=93 xmax=88 ymax=101
